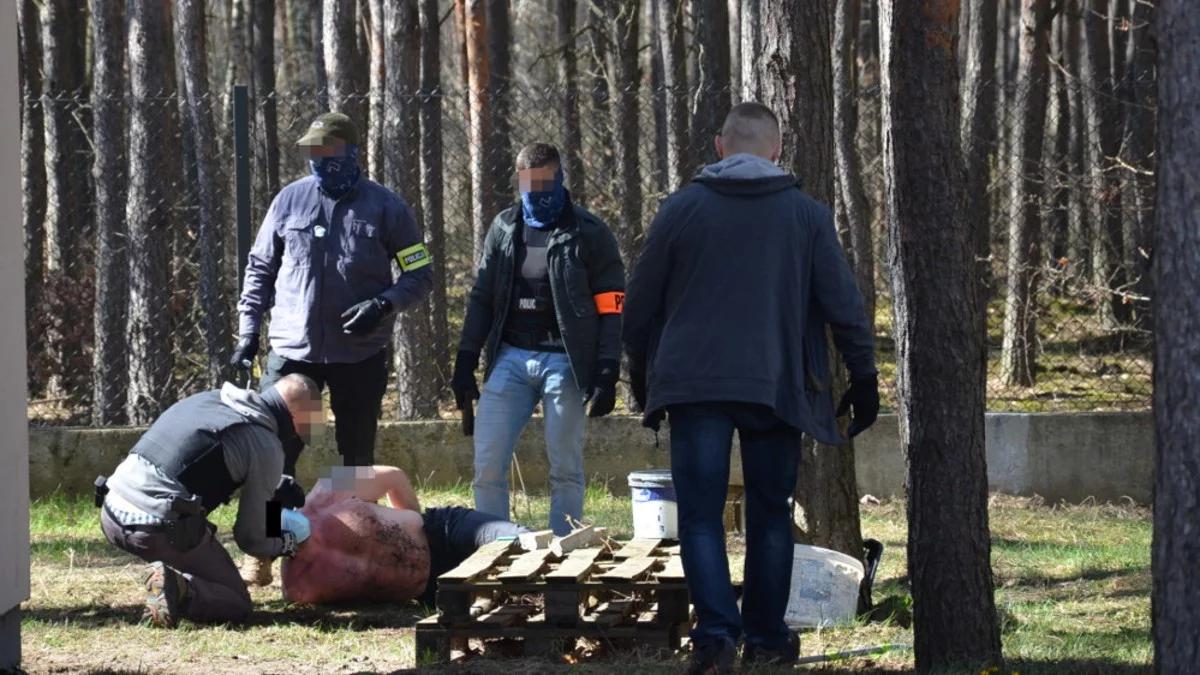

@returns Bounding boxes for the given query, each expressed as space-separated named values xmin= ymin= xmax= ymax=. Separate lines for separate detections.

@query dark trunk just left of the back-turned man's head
xmin=684 ymin=0 xmax=740 ymax=177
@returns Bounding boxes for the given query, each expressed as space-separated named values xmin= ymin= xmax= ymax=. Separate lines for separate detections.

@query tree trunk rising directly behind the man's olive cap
xmin=322 ymin=0 xmax=367 ymax=124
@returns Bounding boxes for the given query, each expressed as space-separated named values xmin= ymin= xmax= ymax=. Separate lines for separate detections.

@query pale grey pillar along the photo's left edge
xmin=0 ymin=2 xmax=29 ymax=671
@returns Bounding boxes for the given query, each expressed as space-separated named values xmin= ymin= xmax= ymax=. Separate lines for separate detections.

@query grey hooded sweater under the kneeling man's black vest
xmin=108 ymin=382 xmax=283 ymax=557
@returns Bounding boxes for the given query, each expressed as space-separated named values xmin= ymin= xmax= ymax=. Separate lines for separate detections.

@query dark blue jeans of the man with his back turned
xmin=667 ymin=402 xmax=800 ymax=650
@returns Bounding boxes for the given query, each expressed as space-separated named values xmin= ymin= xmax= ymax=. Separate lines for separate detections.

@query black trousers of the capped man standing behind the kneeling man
xmin=259 ymin=350 xmax=388 ymax=468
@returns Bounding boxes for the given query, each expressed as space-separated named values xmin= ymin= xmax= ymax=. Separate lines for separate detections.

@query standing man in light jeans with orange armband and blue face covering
xmin=451 ymin=143 xmax=625 ymax=534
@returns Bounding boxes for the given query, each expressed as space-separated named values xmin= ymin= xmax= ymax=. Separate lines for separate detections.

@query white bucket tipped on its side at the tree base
xmin=784 ymin=544 xmax=863 ymax=629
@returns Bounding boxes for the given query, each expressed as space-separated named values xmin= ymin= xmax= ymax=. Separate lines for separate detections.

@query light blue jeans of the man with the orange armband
xmin=474 ymin=345 xmax=587 ymax=534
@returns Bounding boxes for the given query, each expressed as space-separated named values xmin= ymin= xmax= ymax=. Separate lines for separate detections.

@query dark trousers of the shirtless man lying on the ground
xmin=419 ymin=507 xmax=528 ymax=605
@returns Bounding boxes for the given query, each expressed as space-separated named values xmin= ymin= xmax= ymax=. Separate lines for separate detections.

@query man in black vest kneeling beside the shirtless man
xmin=96 ymin=375 xmax=324 ymax=628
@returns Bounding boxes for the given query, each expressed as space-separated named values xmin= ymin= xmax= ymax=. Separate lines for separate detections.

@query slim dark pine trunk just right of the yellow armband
xmin=419 ymin=0 xmax=450 ymax=393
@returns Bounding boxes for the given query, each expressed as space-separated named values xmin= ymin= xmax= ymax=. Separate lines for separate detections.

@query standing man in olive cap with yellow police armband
xmin=233 ymin=113 xmax=433 ymax=584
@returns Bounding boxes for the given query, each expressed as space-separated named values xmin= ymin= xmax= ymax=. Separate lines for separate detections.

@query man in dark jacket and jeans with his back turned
xmin=623 ymin=102 xmax=880 ymax=673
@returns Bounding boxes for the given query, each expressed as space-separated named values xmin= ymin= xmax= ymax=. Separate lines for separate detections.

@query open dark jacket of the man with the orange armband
xmin=458 ymin=196 xmax=625 ymax=392
